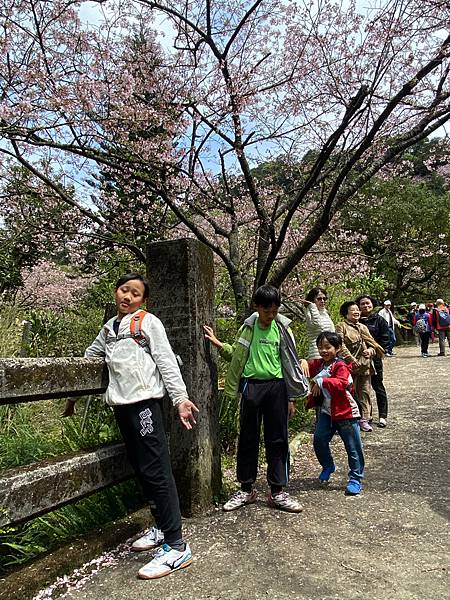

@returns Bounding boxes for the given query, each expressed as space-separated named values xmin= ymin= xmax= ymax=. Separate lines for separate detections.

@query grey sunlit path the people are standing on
xmin=37 ymin=346 xmax=450 ymax=600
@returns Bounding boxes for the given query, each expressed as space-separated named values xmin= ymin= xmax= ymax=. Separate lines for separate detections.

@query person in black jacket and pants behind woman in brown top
xmin=356 ymin=294 xmax=390 ymax=427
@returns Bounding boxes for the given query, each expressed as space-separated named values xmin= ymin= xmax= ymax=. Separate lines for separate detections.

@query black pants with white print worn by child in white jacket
xmin=114 ymin=400 xmax=181 ymax=546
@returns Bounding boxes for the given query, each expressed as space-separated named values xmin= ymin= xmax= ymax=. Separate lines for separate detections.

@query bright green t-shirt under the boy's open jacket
xmin=242 ymin=319 xmax=283 ymax=379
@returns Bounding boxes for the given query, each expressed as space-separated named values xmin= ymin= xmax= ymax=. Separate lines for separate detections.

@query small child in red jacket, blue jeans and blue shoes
xmin=308 ymin=331 xmax=364 ymax=496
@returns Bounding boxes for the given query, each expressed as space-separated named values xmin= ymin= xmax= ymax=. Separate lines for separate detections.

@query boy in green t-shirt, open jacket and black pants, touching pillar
xmin=204 ymin=284 xmax=308 ymax=513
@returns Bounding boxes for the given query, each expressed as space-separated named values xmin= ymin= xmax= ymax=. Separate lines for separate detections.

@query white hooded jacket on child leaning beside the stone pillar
xmin=84 ymin=311 xmax=189 ymax=406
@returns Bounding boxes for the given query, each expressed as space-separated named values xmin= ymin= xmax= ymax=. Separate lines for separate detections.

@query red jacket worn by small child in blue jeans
xmin=306 ymin=358 xmax=360 ymax=421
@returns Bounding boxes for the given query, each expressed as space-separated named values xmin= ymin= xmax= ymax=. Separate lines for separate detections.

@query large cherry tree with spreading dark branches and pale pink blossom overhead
xmin=0 ymin=0 xmax=450 ymax=313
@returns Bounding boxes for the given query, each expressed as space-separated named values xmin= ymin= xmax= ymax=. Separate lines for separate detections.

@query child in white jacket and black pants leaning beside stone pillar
xmin=64 ymin=273 xmax=198 ymax=579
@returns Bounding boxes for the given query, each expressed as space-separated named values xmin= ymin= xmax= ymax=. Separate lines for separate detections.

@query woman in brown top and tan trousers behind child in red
xmin=336 ymin=300 xmax=378 ymax=432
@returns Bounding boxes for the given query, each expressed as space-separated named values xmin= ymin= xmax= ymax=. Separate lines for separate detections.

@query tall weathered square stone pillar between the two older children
xmin=147 ymin=239 xmax=221 ymax=516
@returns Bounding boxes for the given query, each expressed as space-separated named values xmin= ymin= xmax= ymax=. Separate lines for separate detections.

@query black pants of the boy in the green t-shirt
xmin=237 ymin=379 xmax=289 ymax=486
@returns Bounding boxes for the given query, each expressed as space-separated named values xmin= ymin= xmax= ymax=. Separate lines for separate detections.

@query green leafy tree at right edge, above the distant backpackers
xmin=342 ymin=139 xmax=450 ymax=304
